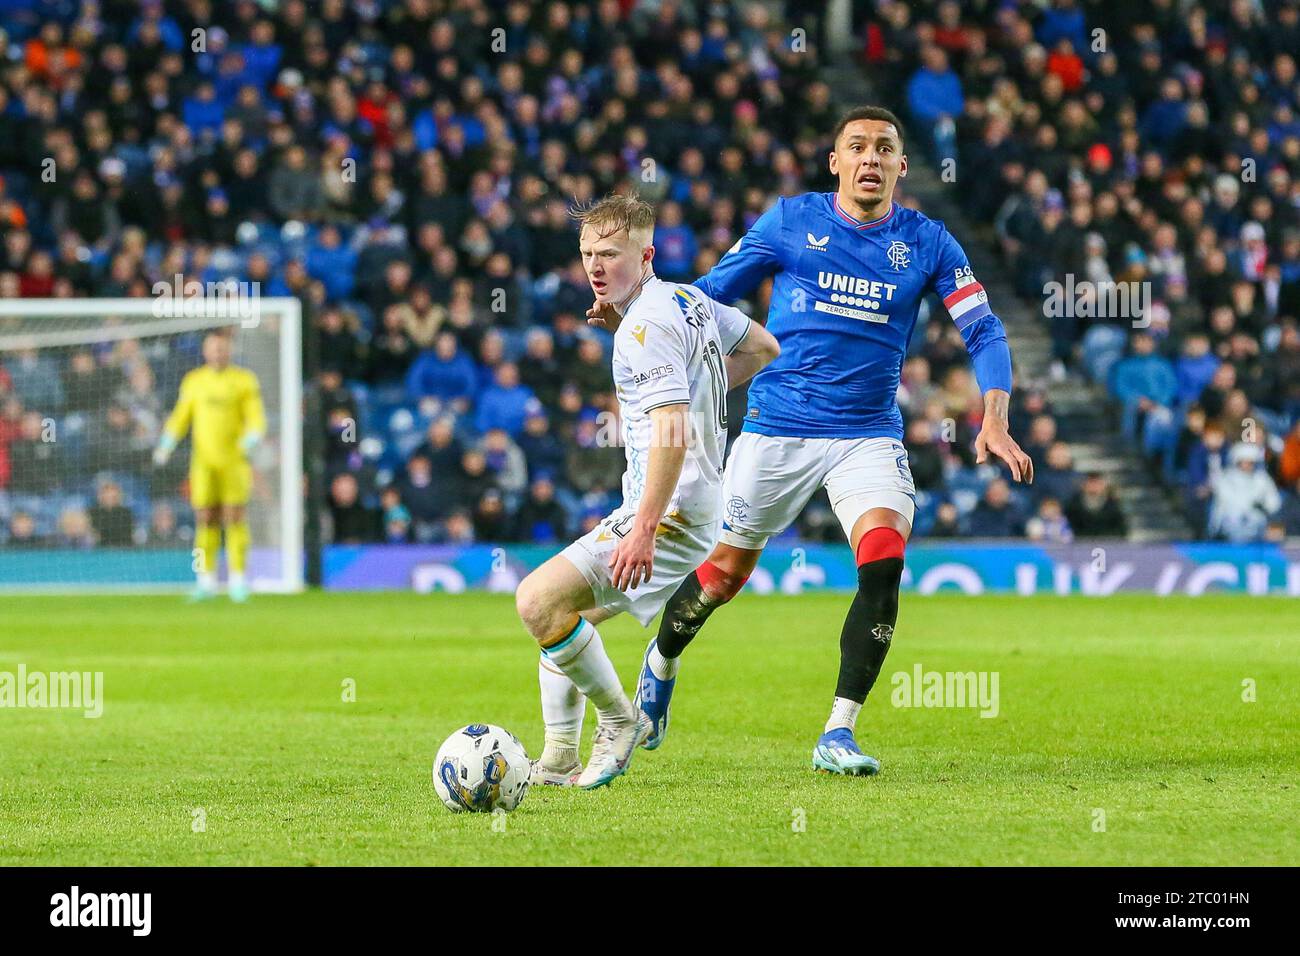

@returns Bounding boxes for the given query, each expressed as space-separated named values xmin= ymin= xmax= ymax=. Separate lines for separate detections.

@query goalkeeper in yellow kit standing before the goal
xmin=153 ymin=333 xmax=267 ymax=602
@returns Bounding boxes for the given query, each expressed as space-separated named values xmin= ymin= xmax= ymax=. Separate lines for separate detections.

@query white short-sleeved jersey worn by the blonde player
xmin=614 ymin=276 xmax=749 ymax=527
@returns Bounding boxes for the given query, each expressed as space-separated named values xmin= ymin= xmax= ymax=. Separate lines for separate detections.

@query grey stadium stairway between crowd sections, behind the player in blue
xmin=823 ymin=55 xmax=1195 ymax=541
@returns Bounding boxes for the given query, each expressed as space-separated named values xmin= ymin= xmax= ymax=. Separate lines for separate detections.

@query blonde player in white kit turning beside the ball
xmin=515 ymin=195 xmax=780 ymax=790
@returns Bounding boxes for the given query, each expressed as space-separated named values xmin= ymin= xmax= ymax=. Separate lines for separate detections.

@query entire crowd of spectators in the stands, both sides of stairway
xmin=0 ymin=0 xmax=1300 ymax=544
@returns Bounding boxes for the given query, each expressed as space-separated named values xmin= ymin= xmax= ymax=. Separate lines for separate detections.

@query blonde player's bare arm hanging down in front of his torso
xmin=610 ymin=403 xmax=690 ymax=591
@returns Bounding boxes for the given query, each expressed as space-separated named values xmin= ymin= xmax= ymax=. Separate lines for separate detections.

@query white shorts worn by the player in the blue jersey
xmin=719 ymin=432 xmax=917 ymax=551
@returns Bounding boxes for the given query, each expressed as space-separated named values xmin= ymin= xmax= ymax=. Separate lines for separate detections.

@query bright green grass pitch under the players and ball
xmin=0 ymin=593 xmax=1300 ymax=865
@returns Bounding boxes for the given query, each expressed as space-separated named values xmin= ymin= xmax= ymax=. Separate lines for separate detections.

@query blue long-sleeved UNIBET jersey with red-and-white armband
xmin=696 ymin=193 xmax=1011 ymax=441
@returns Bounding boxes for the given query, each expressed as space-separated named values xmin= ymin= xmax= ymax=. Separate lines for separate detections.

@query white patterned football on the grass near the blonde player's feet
xmin=433 ymin=723 xmax=529 ymax=813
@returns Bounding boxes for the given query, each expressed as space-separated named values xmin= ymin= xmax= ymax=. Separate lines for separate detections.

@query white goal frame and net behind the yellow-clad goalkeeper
xmin=0 ymin=295 xmax=303 ymax=592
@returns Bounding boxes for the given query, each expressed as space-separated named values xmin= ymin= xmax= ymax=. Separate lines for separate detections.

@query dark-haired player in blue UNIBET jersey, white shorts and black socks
xmin=618 ymin=107 xmax=1034 ymax=775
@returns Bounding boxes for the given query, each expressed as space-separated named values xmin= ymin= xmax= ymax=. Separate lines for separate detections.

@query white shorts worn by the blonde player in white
xmin=560 ymin=507 xmax=722 ymax=627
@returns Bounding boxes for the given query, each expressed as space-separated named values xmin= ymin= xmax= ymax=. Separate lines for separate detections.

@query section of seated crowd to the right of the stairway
xmin=866 ymin=0 xmax=1300 ymax=541
